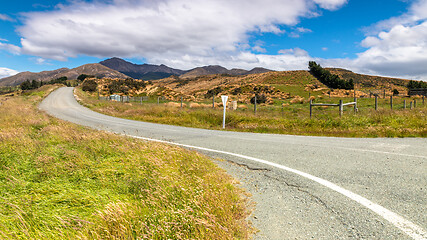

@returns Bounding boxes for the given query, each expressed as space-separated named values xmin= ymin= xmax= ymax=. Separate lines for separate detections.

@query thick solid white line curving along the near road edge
xmin=131 ymin=135 xmax=427 ymax=240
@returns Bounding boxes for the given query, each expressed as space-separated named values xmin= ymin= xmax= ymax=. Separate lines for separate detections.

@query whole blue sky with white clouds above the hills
xmin=0 ymin=0 xmax=427 ymax=80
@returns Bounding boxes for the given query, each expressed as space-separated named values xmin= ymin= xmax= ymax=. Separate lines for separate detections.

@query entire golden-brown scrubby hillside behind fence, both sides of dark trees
xmin=99 ymin=66 xmax=422 ymax=104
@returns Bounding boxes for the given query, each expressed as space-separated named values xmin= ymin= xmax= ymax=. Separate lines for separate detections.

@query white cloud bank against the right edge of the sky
xmin=353 ymin=0 xmax=427 ymax=79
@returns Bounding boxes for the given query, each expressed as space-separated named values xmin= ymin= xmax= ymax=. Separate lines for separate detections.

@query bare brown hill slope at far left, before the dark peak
xmin=0 ymin=63 xmax=128 ymax=86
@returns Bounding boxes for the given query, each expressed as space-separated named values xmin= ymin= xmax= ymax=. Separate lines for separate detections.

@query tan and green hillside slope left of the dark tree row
xmin=124 ymin=71 xmax=329 ymax=104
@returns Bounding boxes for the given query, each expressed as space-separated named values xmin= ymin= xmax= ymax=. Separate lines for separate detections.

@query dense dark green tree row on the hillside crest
xmin=308 ymin=61 xmax=354 ymax=90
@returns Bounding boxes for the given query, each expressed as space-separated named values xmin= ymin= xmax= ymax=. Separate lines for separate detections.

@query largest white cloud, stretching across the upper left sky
xmin=18 ymin=0 xmax=346 ymax=62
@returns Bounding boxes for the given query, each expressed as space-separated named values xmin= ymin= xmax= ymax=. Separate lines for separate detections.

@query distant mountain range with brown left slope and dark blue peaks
xmin=0 ymin=58 xmax=271 ymax=86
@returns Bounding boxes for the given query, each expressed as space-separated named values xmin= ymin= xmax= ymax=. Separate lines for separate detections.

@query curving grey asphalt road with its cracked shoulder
xmin=40 ymin=88 xmax=427 ymax=239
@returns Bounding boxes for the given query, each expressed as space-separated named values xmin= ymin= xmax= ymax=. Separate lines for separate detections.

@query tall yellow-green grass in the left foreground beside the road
xmin=0 ymin=86 xmax=251 ymax=239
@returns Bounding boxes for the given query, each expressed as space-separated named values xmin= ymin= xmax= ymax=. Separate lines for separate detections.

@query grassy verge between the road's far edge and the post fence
xmin=76 ymin=89 xmax=427 ymax=137
